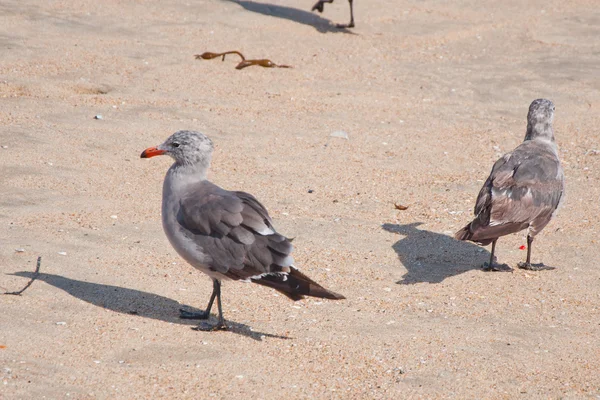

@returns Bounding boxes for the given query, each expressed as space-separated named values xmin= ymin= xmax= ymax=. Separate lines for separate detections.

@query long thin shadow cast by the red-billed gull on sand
xmin=12 ymin=271 xmax=291 ymax=341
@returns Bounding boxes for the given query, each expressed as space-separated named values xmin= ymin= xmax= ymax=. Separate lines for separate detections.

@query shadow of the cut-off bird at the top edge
xmin=223 ymin=0 xmax=356 ymax=35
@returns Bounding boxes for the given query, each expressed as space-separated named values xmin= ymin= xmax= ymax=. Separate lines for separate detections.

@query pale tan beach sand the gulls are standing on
xmin=0 ymin=0 xmax=600 ymax=399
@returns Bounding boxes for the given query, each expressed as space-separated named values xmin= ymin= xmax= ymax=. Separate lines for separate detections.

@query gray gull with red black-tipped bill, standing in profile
xmin=141 ymin=131 xmax=345 ymax=330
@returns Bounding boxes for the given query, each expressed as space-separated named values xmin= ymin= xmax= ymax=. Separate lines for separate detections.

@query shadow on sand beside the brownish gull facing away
xmin=382 ymin=222 xmax=490 ymax=285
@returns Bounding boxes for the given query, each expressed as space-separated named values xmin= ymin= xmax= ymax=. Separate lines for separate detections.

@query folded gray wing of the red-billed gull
xmin=178 ymin=181 xmax=293 ymax=279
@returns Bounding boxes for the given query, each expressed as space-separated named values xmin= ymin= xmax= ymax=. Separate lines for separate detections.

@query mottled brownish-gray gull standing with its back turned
xmin=454 ymin=99 xmax=565 ymax=271
